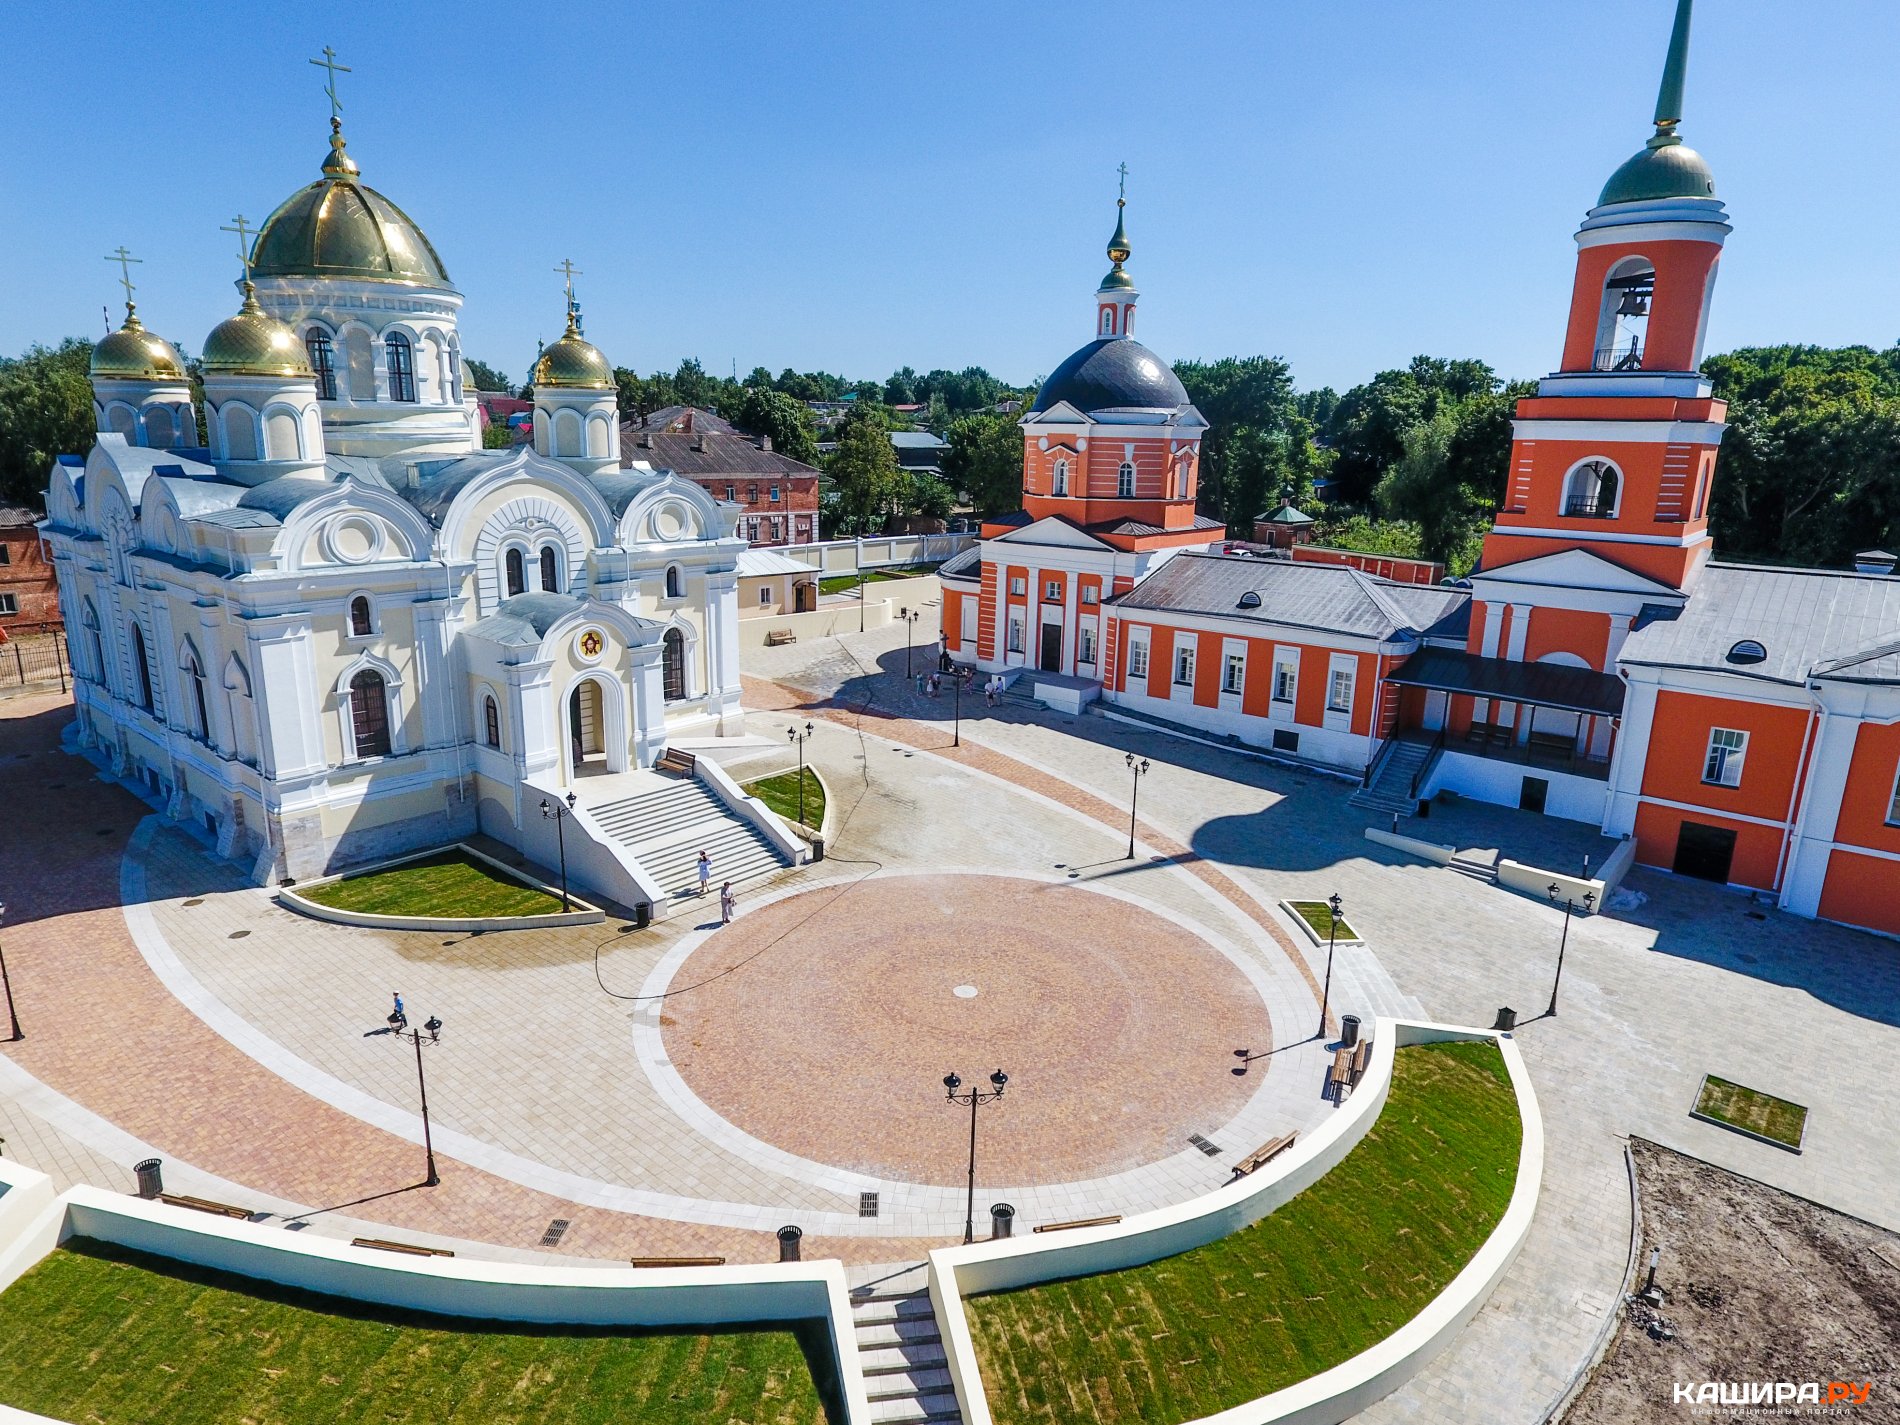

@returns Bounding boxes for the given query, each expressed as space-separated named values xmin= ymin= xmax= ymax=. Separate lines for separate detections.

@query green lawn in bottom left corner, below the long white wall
xmin=0 ymin=1237 xmax=828 ymax=1425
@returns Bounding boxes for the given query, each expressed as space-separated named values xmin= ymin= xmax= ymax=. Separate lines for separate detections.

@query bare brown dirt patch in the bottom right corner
xmin=1564 ymin=1138 xmax=1900 ymax=1425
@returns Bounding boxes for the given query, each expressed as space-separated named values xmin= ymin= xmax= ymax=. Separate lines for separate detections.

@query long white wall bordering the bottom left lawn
xmin=0 ymin=1185 xmax=870 ymax=1425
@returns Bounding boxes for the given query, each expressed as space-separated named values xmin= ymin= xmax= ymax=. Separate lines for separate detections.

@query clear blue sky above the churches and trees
xmin=0 ymin=0 xmax=1900 ymax=388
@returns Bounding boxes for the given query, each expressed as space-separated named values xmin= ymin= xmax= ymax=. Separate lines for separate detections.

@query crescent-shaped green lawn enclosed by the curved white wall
xmin=967 ymin=1043 xmax=1522 ymax=1425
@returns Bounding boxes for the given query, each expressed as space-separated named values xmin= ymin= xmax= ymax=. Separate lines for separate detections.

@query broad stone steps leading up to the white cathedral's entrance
xmin=587 ymin=771 xmax=790 ymax=901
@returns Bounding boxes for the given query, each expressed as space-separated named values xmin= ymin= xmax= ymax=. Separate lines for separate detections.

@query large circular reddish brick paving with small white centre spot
xmin=661 ymin=876 xmax=1271 ymax=1186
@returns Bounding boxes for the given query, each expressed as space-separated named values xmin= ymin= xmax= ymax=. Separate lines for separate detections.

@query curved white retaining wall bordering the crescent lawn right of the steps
xmin=929 ymin=1018 xmax=1543 ymax=1425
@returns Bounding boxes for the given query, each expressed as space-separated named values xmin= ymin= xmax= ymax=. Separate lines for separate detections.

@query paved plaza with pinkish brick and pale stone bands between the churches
xmin=0 ymin=629 xmax=1900 ymax=1421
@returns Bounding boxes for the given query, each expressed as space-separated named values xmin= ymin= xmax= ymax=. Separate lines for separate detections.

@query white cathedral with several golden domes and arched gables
xmin=42 ymin=108 xmax=747 ymax=884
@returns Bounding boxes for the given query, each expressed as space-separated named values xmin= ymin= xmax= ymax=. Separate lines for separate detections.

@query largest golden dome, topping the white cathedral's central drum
xmin=251 ymin=133 xmax=450 ymax=287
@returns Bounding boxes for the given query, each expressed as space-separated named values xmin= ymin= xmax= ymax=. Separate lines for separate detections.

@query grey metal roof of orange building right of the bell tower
xmin=1617 ymin=564 xmax=1900 ymax=684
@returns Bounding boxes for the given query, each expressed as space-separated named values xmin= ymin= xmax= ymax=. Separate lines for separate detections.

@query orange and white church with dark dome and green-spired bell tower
xmin=942 ymin=0 xmax=1900 ymax=950
